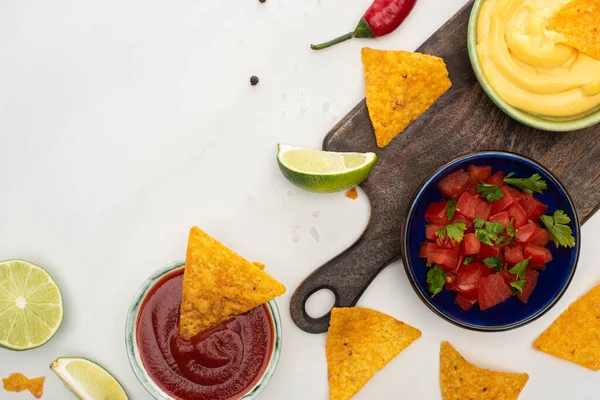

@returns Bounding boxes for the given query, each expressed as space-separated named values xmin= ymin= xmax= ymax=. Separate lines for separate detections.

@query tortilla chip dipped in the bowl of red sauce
xmin=179 ymin=227 xmax=285 ymax=339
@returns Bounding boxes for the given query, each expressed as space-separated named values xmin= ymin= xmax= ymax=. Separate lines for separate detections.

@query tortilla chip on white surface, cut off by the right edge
xmin=533 ymin=285 xmax=600 ymax=371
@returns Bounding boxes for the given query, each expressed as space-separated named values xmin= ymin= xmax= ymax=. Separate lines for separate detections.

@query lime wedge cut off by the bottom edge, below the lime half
xmin=50 ymin=357 xmax=129 ymax=400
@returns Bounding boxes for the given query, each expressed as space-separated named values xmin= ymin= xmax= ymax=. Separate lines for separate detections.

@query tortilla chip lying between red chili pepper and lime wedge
xmin=362 ymin=47 xmax=452 ymax=147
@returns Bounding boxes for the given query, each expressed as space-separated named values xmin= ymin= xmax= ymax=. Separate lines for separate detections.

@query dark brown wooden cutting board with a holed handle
xmin=290 ymin=2 xmax=600 ymax=333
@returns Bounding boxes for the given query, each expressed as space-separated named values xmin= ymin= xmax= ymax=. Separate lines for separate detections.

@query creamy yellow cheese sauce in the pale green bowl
xmin=477 ymin=0 xmax=600 ymax=117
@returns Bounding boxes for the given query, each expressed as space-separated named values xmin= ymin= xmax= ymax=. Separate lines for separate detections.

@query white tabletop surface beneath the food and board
xmin=0 ymin=0 xmax=600 ymax=400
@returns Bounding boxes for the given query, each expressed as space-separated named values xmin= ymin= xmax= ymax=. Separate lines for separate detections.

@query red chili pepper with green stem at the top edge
xmin=310 ymin=0 xmax=417 ymax=50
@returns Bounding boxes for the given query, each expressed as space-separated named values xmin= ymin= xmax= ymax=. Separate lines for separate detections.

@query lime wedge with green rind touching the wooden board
xmin=277 ymin=144 xmax=377 ymax=192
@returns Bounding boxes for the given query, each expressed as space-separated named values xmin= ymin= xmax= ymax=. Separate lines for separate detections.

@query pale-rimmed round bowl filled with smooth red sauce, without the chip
xmin=125 ymin=261 xmax=282 ymax=400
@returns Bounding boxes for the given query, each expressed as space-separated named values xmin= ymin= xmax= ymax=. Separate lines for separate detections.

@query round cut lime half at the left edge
xmin=0 ymin=260 xmax=63 ymax=350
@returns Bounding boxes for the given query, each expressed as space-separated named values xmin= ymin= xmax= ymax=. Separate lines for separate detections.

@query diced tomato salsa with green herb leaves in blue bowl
xmin=419 ymin=165 xmax=552 ymax=310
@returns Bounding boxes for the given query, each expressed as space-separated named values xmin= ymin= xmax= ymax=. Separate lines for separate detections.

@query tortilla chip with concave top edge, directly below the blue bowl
xmin=440 ymin=342 xmax=529 ymax=400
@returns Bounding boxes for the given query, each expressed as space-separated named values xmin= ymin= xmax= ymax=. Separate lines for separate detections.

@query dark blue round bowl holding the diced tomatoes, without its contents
xmin=402 ymin=151 xmax=581 ymax=332
